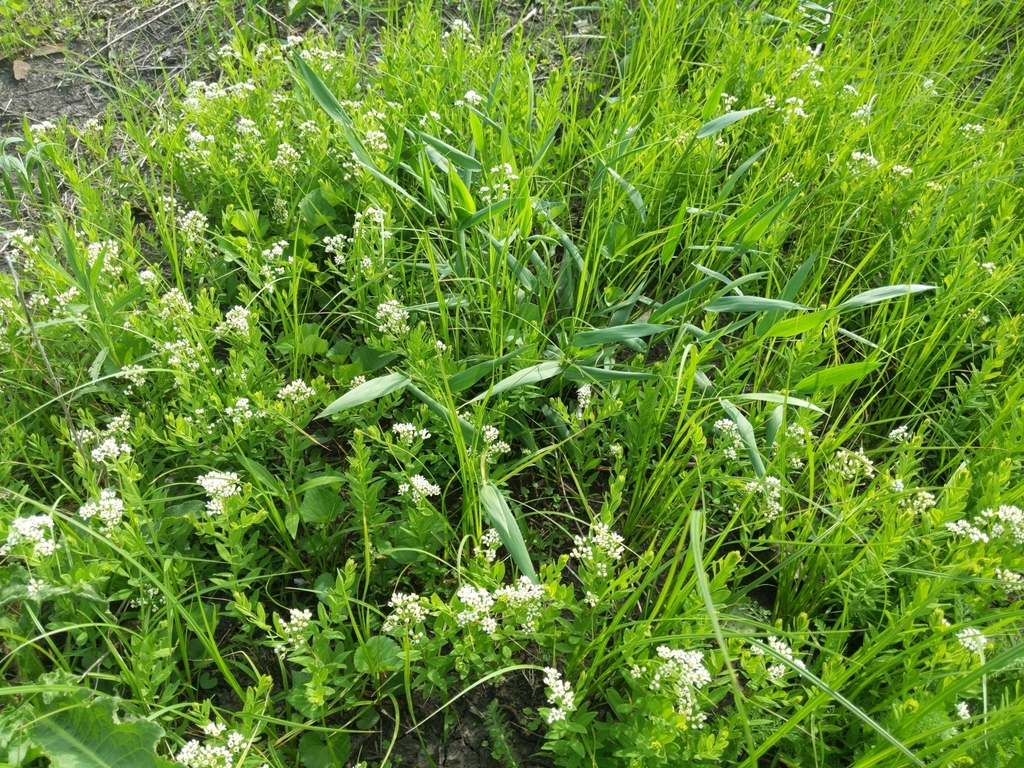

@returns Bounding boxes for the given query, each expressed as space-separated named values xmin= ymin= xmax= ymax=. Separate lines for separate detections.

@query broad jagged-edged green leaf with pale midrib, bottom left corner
xmin=31 ymin=692 xmax=174 ymax=768
